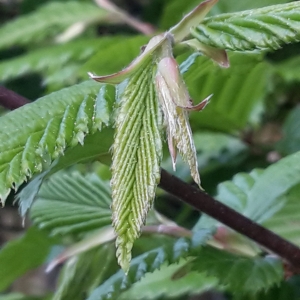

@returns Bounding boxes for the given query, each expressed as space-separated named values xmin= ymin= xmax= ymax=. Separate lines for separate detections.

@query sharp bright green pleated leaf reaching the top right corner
xmin=191 ymin=1 xmax=300 ymax=51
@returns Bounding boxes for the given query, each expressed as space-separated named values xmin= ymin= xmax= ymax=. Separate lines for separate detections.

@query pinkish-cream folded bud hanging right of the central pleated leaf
xmin=156 ymin=57 xmax=211 ymax=185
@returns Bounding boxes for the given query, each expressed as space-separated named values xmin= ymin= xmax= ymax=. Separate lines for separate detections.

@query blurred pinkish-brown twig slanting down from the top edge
xmin=94 ymin=0 xmax=155 ymax=35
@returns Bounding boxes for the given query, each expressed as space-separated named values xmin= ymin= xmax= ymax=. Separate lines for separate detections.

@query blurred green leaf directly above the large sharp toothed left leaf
xmin=0 ymin=38 xmax=103 ymax=82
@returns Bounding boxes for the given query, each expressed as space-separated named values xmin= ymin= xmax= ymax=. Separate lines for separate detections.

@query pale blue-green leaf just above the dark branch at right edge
xmin=196 ymin=152 xmax=300 ymax=228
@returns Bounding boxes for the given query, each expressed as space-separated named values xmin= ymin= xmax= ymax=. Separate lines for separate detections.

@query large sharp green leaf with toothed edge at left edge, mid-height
xmin=0 ymin=81 xmax=114 ymax=204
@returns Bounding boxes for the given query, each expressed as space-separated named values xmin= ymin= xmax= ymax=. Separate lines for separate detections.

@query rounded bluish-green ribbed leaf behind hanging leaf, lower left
xmin=31 ymin=171 xmax=111 ymax=235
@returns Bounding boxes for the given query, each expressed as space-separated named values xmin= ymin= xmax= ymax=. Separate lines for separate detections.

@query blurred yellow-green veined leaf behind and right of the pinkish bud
xmin=184 ymin=53 xmax=272 ymax=132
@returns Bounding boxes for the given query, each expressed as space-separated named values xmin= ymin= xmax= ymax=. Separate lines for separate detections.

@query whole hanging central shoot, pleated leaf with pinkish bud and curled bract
xmin=90 ymin=33 xmax=208 ymax=272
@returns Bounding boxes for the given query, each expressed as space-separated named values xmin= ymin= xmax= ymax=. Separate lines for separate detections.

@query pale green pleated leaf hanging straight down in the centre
xmin=111 ymin=59 xmax=162 ymax=270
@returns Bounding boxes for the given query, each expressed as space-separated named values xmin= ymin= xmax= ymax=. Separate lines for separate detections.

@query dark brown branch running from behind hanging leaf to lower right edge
xmin=159 ymin=169 xmax=300 ymax=269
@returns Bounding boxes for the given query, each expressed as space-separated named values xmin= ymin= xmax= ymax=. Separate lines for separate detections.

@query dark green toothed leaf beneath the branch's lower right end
xmin=191 ymin=247 xmax=284 ymax=294
